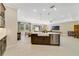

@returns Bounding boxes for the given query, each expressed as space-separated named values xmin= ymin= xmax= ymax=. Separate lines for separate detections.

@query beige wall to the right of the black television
xmin=59 ymin=21 xmax=79 ymax=35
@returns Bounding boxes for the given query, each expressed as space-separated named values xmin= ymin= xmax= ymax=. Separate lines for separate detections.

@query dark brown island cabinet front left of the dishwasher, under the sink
xmin=31 ymin=34 xmax=50 ymax=45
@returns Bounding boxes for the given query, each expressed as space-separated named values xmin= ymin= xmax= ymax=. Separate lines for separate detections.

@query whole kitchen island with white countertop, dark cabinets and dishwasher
xmin=31 ymin=32 xmax=60 ymax=46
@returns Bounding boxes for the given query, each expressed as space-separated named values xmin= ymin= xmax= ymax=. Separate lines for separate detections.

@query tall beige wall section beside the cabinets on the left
xmin=5 ymin=7 xmax=17 ymax=47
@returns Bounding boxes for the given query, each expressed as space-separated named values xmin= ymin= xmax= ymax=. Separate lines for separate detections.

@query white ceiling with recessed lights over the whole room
xmin=5 ymin=3 xmax=79 ymax=22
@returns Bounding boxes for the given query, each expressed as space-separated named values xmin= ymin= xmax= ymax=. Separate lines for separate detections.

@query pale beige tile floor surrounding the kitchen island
xmin=4 ymin=36 xmax=79 ymax=56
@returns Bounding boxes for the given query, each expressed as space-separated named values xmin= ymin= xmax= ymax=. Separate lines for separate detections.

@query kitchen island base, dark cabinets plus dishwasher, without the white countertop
xmin=31 ymin=34 xmax=60 ymax=46
